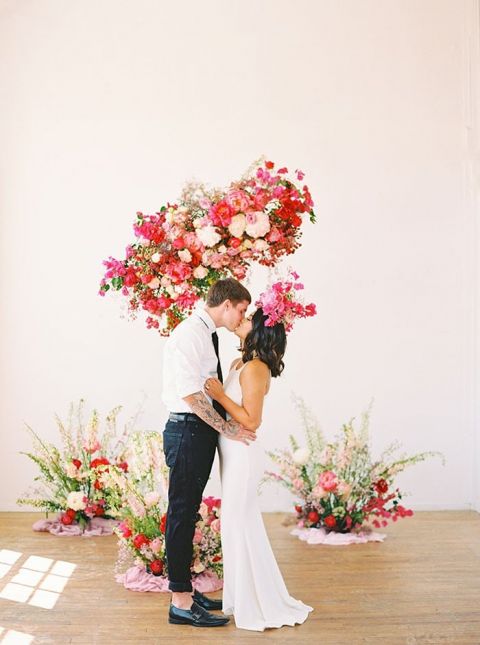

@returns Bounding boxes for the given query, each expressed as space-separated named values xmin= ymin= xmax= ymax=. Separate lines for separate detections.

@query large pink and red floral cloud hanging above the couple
xmin=99 ymin=160 xmax=315 ymax=336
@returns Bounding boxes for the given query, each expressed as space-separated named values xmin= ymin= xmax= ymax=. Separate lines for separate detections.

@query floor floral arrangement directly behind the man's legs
xmin=109 ymin=433 xmax=223 ymax=581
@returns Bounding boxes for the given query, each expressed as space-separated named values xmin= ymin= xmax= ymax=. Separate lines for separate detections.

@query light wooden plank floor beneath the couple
xmin=0 ymin=512 xmax=480 ymax=645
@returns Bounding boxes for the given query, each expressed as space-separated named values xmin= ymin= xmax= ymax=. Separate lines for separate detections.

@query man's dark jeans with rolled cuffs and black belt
xmin=163 ymin=414 xmax=218 ymax=591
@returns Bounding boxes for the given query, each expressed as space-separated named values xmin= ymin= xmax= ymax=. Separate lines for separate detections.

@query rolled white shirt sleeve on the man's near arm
xmin=173 ymin=329 xmax=209 ymax=399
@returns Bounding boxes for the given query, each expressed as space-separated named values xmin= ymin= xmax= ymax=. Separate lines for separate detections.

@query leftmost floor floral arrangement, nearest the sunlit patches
xmin=17 ymin=400 xmax=135 ymax=529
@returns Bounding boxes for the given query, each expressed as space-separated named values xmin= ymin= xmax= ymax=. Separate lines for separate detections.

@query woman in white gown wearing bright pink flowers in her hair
xmin=205 ymin=276 xmax=313 ymax=631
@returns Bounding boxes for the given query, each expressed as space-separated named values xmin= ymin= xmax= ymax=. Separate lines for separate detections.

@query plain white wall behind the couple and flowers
xmin=0 ymin=0 xmax=480 ymax=510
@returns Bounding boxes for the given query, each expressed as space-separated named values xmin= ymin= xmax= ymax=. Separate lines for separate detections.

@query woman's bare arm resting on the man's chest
xmin=205 ymin=360 xmax=270 ymax=431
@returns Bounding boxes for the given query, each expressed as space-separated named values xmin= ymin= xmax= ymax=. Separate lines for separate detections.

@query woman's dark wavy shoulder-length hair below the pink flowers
xmin=242 ymin=309 xmax=287 ymax=376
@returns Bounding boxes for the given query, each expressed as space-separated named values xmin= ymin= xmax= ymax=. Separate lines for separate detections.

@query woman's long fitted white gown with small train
xmin=219 ymin=368 xmax=313 ymax=631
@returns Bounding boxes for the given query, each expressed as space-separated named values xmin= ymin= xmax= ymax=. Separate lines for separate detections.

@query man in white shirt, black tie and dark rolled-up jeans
xmin=162 ymin=278 xmax=255 ymax=627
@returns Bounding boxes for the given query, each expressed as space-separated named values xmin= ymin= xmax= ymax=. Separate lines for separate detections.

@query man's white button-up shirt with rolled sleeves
xmin=162 ymin=308 xmax=217 ymax=412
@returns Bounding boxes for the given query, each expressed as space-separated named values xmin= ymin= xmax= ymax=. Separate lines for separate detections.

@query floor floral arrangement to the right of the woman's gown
xmin=263 ymin=399 xmax=441 ymax=533
